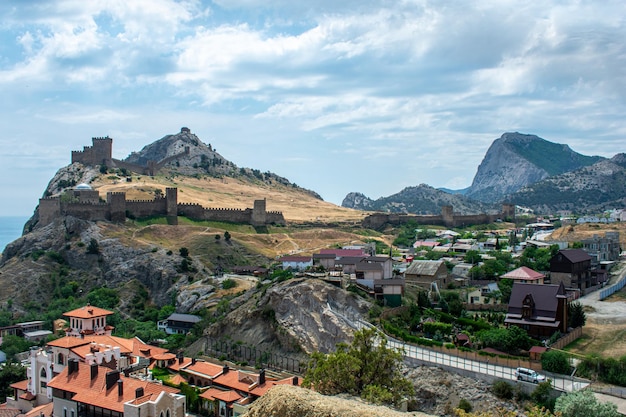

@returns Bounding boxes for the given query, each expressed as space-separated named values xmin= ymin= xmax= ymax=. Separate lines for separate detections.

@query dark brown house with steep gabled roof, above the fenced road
xmin=504 ymin=282 xmax=567 ymax=340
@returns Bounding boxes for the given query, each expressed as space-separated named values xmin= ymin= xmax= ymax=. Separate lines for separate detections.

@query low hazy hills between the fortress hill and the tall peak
xmin=341 ymin=184 xmax=497 ymax=214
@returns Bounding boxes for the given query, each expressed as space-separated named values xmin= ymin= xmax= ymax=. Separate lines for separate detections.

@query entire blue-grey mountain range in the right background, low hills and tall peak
xmin=341 ymin=132 xmax=608 ymax=214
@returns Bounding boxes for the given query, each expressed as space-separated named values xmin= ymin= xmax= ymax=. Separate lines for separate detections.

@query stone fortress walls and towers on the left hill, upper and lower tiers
xmin=38 ymin=128 xmax=285 ymax=226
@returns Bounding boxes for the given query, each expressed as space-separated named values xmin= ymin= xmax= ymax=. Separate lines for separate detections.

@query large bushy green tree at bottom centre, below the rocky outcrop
xmin=303 ymin=329 xmax=414 ymax=404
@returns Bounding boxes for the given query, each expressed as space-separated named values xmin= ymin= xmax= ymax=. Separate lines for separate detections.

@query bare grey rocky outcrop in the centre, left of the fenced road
xmin=191 ymin=279 xmax=371 ymax=356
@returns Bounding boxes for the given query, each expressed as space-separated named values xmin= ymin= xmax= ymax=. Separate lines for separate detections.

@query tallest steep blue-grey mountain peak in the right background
xmin=465 ymin=132 xmax=603 ymax=203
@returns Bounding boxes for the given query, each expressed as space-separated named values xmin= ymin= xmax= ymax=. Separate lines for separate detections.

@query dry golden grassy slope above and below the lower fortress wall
xmin=91 ymin=171 xmax=393 ymax=258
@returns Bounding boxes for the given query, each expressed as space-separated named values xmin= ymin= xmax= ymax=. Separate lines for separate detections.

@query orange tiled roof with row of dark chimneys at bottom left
xmin=48 ymin=362 xmax=180 ymax=412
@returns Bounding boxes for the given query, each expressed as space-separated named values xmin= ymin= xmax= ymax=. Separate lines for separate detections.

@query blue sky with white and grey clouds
xmin=0 ymin=0 xmax=626 ymax=216
